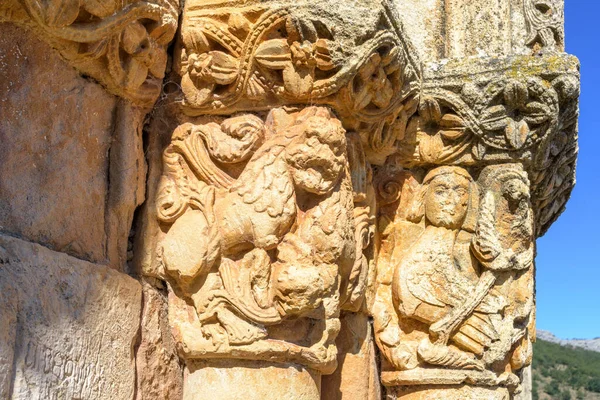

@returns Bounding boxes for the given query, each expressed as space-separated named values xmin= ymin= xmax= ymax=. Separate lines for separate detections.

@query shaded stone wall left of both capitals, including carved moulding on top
xmin=0 ymin=1 xmax=178 ymax=400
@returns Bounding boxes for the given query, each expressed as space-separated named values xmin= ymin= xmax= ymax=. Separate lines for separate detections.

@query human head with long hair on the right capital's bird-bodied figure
xmin=412 ymin=167 xmax=478 ymax=229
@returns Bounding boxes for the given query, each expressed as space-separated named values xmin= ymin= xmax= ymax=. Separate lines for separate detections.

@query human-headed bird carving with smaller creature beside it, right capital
xmin=375 ymin=165 xmax=533 ymax=387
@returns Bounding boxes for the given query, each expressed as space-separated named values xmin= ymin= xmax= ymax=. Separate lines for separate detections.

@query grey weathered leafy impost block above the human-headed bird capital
xmin=398 ymin=55 xmax=579 ymax=236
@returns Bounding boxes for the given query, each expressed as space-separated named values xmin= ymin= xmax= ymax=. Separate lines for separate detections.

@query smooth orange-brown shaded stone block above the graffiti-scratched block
xmin=0 ymin=23 xmax=116 ymax=261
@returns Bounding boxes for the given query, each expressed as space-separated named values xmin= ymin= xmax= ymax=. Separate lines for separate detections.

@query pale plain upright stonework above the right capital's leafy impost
xmin=394 ymin=0 xmax=564 ymax=62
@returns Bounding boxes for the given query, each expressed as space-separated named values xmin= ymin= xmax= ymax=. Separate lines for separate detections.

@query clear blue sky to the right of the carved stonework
xmin=536 ymin=0 xmax=600 ymax=338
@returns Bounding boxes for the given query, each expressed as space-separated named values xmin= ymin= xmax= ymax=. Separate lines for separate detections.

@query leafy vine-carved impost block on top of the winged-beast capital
xmin=179 ymin=0 xmax=420 ymax=163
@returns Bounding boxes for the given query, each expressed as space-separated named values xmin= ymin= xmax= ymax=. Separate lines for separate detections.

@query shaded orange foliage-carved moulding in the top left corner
xmin=0 ymin=0 xmax=179 ymax=107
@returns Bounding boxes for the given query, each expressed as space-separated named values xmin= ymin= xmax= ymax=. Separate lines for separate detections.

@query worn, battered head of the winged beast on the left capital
xmin=286 ymin=107 xmax=346 ymax=195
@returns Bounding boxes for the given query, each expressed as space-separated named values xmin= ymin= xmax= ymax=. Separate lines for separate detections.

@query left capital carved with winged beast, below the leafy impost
xmin=152 ymin=107 xmax=373 ymax=371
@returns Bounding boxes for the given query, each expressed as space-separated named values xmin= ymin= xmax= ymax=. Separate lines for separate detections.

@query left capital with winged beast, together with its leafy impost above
xmin=147 ymin=1 xmax=420 ymax=373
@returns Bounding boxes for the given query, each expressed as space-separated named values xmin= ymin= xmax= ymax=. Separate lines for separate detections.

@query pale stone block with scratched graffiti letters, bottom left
xmin=0 ymin=236 xmax=141 ymax=400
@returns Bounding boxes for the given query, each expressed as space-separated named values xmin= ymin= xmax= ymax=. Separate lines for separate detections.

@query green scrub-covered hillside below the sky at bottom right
xmin=532 ymin=338 xmax=600 ymax=400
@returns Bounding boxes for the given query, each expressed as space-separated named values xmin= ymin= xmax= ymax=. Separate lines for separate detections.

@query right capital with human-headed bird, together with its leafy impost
xmin=371 ymin=1 xmax=579 ymax=399
